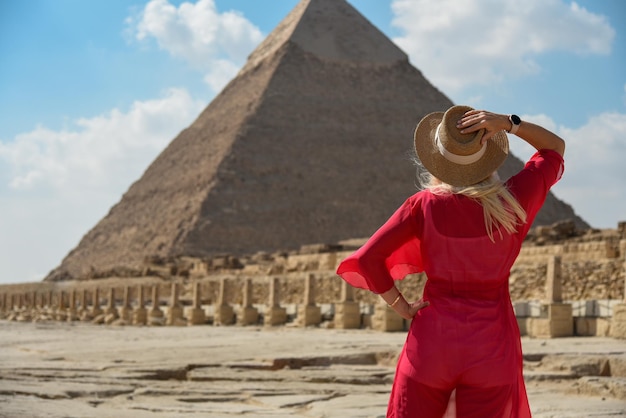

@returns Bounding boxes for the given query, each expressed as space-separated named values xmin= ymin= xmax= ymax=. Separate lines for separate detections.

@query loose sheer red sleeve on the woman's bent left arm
xmin=337 ymin=193 xmax=423 ymax=293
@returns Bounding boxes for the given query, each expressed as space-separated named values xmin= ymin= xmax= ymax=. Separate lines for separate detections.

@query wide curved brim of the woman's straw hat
xmin=415 ymin=112 xmax=509 ymax=187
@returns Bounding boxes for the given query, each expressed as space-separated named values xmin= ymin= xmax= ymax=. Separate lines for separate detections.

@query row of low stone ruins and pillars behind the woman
xmin=0 ymin=222 xmax=626 ymax=338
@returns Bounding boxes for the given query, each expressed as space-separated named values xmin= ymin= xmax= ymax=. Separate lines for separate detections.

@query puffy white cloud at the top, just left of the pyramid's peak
xmin=128 ymin=0 xmax=263 ymax=91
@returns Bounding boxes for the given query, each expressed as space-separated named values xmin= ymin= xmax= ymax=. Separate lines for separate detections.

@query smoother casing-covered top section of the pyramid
xmin=243 ymin=0 xmax=408 ymax=71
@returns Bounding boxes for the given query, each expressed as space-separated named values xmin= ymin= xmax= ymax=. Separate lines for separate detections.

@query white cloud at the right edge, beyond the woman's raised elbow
xmin=511 ymin=112 xmax=626 ymax=228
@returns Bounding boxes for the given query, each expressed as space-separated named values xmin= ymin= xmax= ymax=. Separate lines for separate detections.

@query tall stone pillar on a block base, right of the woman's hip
xmin=529 ymin=256 xmax=574 ymax=338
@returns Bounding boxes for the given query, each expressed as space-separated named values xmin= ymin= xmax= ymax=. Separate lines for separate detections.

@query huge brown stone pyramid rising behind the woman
xmin=46 ymin=0 xmax=584 ymax=280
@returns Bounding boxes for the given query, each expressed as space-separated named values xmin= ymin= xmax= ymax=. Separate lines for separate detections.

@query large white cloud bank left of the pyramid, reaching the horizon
xmin=0 ymin=89 xmax=205 ymax=282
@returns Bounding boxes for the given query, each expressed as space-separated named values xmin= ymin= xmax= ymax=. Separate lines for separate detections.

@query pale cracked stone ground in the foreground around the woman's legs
xmin=0 ymin=321 xmax=626 ymax=418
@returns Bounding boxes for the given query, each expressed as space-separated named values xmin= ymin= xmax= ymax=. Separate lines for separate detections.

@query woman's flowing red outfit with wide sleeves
xmin=337 ymin=150 xmax=563 ymax=418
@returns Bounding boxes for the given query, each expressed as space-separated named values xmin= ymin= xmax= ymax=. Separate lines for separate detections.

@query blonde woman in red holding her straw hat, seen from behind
xmin=337 ymin=106 xmax=565 ymax=418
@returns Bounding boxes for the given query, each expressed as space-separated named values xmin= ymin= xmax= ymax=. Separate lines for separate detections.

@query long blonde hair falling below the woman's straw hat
xmin=419 ymin=170 xmax=526 ymax=242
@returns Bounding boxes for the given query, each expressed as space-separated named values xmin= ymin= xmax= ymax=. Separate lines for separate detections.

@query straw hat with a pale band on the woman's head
xmin=415 ymin=106 xmax=509 ymax=186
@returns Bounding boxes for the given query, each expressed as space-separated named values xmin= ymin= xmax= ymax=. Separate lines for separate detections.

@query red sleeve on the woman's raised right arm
xmin=506 ymin=149 xmax=564 ymax=235
